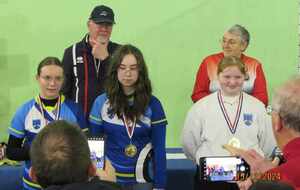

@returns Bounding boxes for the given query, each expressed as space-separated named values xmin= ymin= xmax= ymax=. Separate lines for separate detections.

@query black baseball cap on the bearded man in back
xmin=89 ymin=5 xmax=115 ymax=24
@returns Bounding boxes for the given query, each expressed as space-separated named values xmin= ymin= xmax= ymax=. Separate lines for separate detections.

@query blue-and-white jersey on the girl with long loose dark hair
xmin=89 ymin=94 xmax=167 ymax=188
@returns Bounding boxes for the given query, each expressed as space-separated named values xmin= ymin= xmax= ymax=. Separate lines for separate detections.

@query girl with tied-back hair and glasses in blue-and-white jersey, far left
xmin=6 ymin=57 xmax=86 ymax=190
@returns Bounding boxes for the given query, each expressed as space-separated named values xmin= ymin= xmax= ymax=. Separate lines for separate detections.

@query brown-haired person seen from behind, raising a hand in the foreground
xmin=29 ymin=120 xmax=120 ymax=190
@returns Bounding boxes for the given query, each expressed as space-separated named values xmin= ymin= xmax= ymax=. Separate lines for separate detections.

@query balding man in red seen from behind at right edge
xmin=239 ymin=76 xmax=300 ymax=190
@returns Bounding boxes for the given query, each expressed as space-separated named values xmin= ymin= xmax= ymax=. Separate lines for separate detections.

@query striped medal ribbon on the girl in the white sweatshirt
xmin=218 ymin=91 xmax=243 ymax=134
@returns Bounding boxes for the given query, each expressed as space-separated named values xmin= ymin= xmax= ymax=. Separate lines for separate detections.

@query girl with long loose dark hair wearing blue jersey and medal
xmin=89 ymin=45 xmax=167 ymax=190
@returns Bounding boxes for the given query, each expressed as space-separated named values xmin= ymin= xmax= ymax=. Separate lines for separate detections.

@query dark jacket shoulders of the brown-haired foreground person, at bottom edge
xmin=45 ymin=178 xmax=121 ymax=190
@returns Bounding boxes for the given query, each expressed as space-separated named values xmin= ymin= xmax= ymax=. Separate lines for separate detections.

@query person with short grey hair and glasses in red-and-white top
xmin=192 ymin=25 xmax=268 ymax=106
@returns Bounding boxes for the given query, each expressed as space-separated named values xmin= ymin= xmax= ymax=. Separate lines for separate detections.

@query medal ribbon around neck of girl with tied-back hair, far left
xmin=36 ymin=96 xmax=61 ymax=125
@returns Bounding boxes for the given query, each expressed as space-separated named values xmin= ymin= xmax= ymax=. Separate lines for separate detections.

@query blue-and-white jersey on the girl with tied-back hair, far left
xmin=8 ymin=96 xmax=87 ymax=189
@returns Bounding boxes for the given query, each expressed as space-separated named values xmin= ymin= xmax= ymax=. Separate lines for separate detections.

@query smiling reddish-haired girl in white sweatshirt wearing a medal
xmin=182 ymin=57 xmax=275 ymax=189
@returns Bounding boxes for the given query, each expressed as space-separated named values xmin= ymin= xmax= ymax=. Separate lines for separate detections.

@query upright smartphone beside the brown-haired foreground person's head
xmin=88 ymin=137 xmax=105 ymax=169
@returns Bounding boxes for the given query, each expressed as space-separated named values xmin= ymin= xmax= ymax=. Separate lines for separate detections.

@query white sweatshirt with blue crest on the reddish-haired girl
xmin=181 ymin=92 xmax=275 ymax=164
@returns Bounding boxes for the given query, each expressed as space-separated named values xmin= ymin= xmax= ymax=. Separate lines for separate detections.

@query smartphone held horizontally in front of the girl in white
xmin=199 ymin=156 xmax=250 ymax=182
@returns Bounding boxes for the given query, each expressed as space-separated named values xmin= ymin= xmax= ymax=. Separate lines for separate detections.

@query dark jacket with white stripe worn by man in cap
xmin=62 ymin=35 xmax=120 ymax=119
